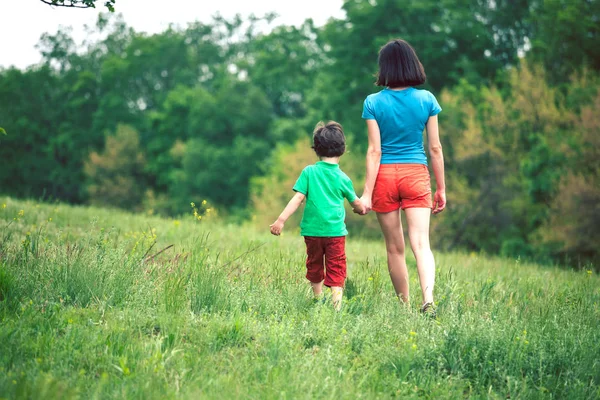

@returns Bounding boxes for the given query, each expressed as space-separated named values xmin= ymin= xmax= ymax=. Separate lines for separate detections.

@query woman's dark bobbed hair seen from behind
xmin=375 ymin=39 xmax=427 ymax=88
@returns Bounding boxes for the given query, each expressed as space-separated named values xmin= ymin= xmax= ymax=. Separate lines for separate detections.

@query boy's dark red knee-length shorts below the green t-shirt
xmin=304 ymin=236 xmax=346 ymax=287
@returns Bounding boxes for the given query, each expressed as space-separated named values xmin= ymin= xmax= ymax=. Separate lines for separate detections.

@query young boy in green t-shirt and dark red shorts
xmin=271 ymin=121 xmax=364 ymax=310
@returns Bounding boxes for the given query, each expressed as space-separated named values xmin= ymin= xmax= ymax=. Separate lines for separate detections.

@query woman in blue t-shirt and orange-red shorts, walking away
xmin=361 ymin=40 xmax=446 ymax=318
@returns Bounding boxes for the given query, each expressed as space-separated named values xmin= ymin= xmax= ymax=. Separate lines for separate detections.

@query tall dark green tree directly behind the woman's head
xmin=311 ymin=0 xmax=527 ymax=144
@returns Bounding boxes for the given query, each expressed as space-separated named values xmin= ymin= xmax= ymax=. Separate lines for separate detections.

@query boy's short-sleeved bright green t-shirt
xmin=294 ymin=161 xmax=356 ymax=237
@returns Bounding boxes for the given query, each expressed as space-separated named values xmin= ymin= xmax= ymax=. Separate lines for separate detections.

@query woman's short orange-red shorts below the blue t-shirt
xmin=372 ymin=164 xmax=433 ymax=213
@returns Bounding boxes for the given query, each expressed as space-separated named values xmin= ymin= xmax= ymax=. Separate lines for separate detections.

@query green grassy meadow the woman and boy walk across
xmin=0 ymin=197 xmax=600 ymax=399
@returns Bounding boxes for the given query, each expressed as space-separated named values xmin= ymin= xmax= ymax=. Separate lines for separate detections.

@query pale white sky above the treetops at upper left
xmin=0 ymin=0 xmax=344 ymax=68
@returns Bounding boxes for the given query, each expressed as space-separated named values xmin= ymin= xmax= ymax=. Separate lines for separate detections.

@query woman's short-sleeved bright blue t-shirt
xmin=362 ymin=87 xmax=442 ymax=165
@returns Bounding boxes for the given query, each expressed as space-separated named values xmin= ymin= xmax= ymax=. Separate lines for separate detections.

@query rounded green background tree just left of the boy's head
xmin=166 ymin=76 xmax=273 ymax=214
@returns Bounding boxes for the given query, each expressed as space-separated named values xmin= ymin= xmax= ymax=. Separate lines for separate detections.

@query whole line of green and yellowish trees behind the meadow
xmin=0 ymin=0 xmax=600 ymax=266
